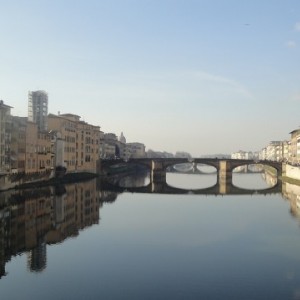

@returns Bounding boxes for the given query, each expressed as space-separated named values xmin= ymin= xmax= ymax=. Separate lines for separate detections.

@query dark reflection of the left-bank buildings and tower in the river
xmin=0 ymin=180 xmax=100 ymax=278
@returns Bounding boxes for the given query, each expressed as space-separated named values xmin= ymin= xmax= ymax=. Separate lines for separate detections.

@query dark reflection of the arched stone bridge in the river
xmin=101 ymin=180 xmax=282 ymax=196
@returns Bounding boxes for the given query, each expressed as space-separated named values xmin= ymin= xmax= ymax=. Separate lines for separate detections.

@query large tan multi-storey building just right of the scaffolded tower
xmin=48 ymin=114 xmax=100 ymax=173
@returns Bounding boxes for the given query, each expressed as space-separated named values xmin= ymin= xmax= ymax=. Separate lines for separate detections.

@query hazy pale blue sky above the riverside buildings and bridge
xmin=0 ymin=0 xmax=300 ymax=157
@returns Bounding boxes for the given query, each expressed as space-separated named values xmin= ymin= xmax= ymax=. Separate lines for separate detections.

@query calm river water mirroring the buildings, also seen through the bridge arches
xmin=0 ymin=174 xmax=300 ymax=299
